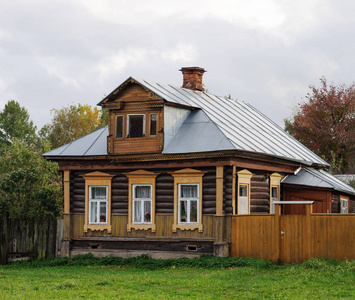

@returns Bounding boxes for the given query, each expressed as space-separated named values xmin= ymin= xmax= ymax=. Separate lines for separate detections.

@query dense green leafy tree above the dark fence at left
xmin=0 ymin=139 xmax=62 ymax=220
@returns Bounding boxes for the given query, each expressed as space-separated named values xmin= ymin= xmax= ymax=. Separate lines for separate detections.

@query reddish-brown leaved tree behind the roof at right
xmin=285 ymin=78 xmax=355 ymax=172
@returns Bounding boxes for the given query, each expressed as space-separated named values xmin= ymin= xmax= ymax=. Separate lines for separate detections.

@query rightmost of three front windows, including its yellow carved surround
xmin=170 ymin=169 xmax=205 ymax=232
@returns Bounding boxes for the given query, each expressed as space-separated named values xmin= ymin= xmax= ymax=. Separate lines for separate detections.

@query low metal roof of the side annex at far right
xmin=281 ymin=168 xmax=355 ymax=195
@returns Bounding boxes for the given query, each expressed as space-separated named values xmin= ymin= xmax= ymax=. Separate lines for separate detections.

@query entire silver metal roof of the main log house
xmin=44 ymin=78 xmax=328 ymax=166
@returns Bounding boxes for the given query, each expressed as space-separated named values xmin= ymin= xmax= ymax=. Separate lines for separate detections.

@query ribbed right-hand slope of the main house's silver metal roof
xmin=134 ymin=79 xmax=328 ymax=166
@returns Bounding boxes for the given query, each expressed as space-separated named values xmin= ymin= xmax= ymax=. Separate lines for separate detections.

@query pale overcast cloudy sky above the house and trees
xmin=0 ymin=0 xmax=355 ymax=129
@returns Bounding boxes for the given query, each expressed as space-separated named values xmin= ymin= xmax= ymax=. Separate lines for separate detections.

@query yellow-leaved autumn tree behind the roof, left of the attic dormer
xmin=39 ymin=104 xmax=108 ymax=148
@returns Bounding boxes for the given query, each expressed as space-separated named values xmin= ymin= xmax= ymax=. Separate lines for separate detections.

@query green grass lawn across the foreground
xmin=0 ymin=257 xmax=355 ymax=299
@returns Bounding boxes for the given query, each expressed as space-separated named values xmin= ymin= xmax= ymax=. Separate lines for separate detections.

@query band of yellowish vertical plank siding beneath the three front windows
xmin=71 ymin=214 xmax=214 ymax=239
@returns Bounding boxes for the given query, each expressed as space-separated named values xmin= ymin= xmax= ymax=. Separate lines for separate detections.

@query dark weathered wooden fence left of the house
xmin=0 ymin=217 xmax=57 ymax=264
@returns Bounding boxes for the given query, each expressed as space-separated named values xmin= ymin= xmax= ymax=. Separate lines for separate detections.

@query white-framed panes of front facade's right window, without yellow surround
xmin=178 ymin=184 xmax=199 ymax=224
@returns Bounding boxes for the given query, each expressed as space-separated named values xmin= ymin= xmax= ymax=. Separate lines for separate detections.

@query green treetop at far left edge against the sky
xmin=0 ymin=100 xmax=36 ymax=152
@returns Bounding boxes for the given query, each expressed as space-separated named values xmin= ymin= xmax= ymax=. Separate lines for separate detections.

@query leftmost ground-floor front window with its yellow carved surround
xmin=83 ymin=172 xmax=113 ymax=233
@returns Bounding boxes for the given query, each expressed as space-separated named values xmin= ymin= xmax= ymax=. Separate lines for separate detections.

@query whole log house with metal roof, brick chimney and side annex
xmin=44 ymin=67 xmax=355 ymax=258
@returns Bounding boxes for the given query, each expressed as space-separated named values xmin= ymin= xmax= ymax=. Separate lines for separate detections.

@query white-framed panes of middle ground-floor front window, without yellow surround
xmin=132 ymin=184 xmax=152 ymax=223
